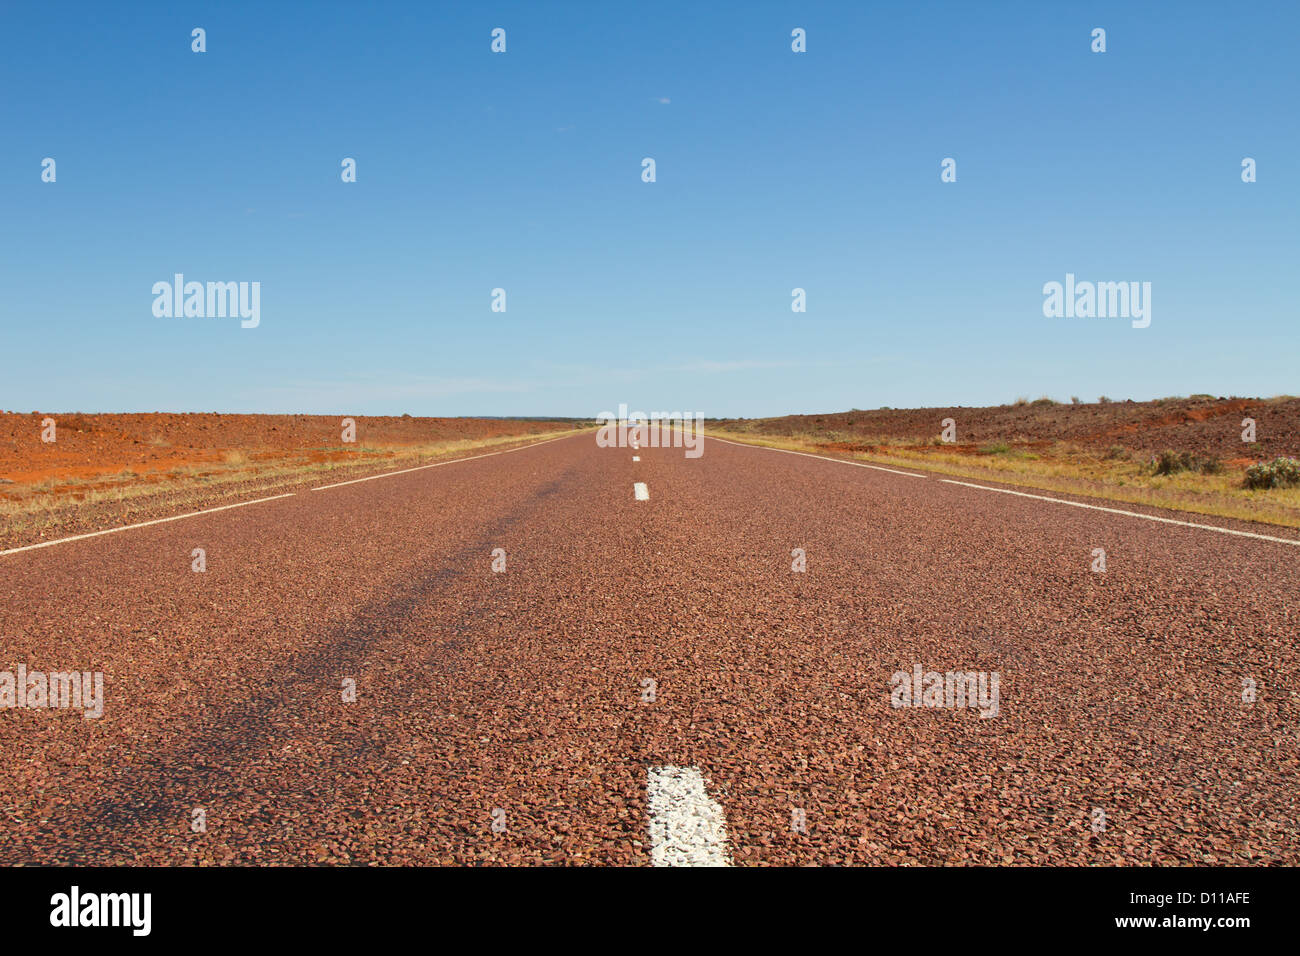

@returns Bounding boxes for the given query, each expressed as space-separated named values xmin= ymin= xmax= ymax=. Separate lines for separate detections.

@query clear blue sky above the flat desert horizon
xmin=0 ymin=0 xmax=1300 ymax=416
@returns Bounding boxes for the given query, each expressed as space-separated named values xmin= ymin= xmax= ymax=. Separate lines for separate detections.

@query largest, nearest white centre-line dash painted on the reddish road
xmin=646 ymin=767 xmax=731 ymax=866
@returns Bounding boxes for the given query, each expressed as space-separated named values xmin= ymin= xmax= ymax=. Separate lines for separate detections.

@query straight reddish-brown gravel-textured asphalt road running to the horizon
xmin=0 ymin=434 xmax=1300 ymax=865
